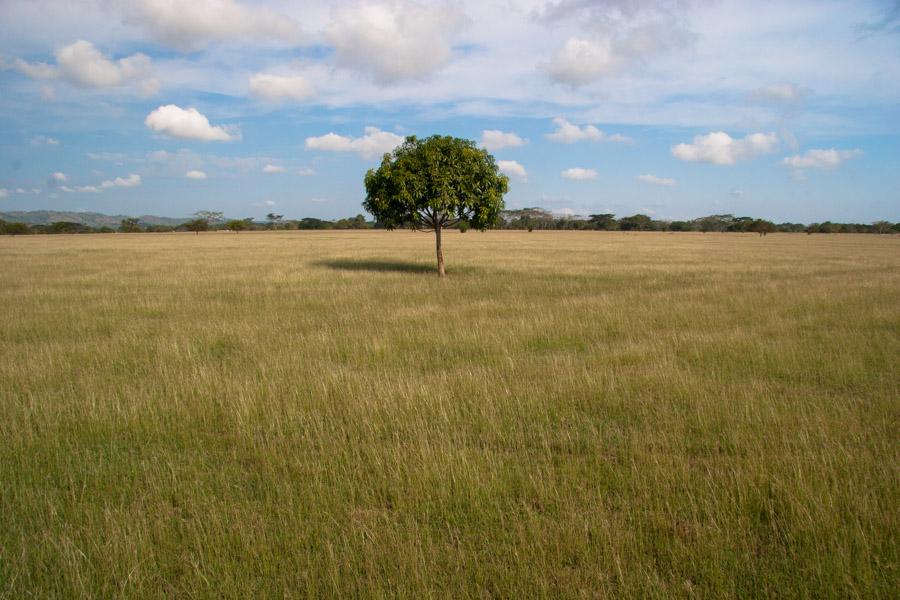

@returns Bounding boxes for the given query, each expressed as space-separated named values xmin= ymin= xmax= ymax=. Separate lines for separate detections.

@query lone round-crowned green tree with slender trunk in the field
xmin=363 ymin=135 xmax=509 ymax=277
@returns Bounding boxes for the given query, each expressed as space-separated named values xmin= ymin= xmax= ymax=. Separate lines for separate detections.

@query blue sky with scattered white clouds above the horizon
xmin=0 ymin=0 xmax=900 ymax=223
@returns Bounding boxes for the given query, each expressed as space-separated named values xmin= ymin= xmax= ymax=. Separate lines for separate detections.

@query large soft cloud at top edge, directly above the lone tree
xmin=325 ymin=1 xmax=466 ymax=83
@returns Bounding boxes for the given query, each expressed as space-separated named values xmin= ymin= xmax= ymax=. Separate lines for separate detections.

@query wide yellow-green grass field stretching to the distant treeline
xmin=0 ymin=231 xmax=900 ymax=598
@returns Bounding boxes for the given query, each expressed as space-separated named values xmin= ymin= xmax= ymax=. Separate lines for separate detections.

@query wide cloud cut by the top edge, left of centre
xmin=131 ymin=0 xmax=301 ymax=50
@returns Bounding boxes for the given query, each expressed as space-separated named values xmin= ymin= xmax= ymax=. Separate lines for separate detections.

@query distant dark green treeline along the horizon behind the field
xmin=0 ymin=208 xmax=900 ymax=235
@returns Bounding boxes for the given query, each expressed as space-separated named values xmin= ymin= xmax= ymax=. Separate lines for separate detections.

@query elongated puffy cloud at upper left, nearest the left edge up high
xmin=13 ymin=40 xmax=159 ymax=96
